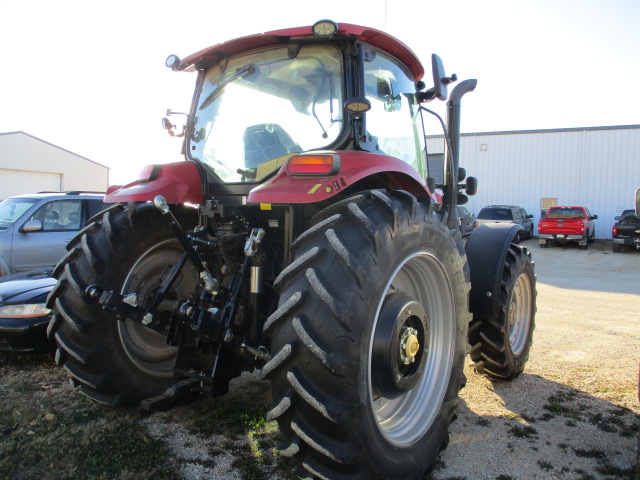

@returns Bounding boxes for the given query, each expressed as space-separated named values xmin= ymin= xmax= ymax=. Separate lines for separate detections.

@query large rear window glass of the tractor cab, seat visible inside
xmin=189 ymin=44 xmax=342 ymax=182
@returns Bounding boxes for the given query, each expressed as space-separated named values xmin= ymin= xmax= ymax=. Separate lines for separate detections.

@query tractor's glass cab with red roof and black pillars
xmin=167 ymin=21 xmax=444 ymax=193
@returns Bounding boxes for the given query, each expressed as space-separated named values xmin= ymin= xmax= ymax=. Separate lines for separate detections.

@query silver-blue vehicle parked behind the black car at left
xmin=0 ymin=192 xmax=107 ymax=277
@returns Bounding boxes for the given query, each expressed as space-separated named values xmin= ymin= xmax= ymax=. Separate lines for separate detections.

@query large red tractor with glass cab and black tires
xmin=48 ymin=21 xmax=535 ymax=479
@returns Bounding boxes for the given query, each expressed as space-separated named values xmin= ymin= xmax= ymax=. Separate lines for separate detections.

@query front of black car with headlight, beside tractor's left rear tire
xmin=0 ymin=270 xmax=56 ymax=353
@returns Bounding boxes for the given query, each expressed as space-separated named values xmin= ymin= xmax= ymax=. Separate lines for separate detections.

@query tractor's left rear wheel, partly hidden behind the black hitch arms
xmin=48 ymin=204 xmax=197 ymax=406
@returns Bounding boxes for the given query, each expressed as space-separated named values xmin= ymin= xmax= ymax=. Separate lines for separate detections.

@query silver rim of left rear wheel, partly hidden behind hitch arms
xmin=118 ymin=241 xmax=197 ymax=377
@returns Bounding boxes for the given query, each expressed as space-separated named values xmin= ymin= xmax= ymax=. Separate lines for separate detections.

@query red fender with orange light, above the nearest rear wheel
xmin=247 ymin=151 xmax=435 ymax=204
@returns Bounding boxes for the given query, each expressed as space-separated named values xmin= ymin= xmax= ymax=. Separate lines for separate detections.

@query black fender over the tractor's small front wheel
xmin=464 ymin=223 xmax=523 ymax=318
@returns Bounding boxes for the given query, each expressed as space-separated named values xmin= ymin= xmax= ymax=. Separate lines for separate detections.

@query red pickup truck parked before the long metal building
xmin=538 ymin=207 xmax=598 ymax=250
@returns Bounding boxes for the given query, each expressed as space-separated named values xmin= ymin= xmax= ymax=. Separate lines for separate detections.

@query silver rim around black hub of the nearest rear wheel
xmin=368 ymin=252 xmax=456 ymax=446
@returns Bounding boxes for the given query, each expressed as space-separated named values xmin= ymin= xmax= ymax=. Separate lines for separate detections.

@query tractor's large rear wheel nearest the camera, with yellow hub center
xmin=263 ymin=191 xmax=469 ymax=480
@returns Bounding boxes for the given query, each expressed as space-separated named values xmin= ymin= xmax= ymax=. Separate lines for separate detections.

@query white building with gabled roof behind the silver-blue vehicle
xmin=0 ymin=132 xmax=109 ymax=199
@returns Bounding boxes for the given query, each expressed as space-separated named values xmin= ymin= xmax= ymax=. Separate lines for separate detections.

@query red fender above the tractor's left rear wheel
xmin=104 ymin=161 xmax=203 ymax=204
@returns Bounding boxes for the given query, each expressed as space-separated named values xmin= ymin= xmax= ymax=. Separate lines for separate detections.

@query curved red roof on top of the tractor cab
xmin=175 ymin=23 xmax=424 ymax=81
